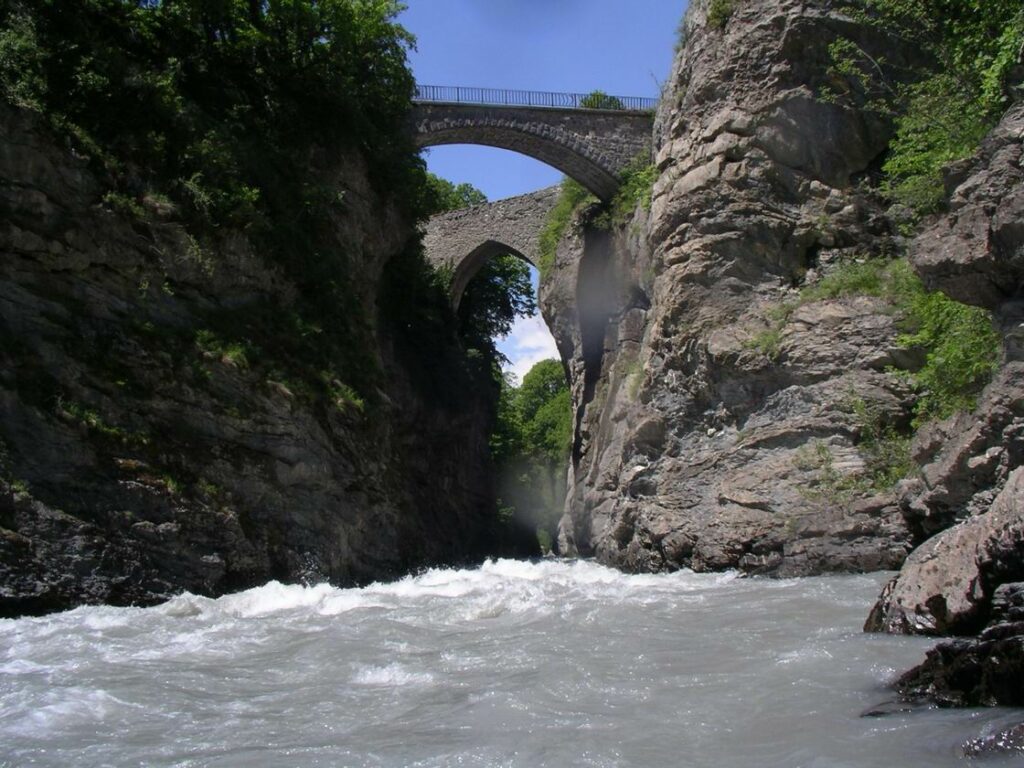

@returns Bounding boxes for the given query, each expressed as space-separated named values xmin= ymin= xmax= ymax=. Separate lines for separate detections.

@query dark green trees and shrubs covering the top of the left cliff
xmin=0 ymin=0 xmax=452 ymax=421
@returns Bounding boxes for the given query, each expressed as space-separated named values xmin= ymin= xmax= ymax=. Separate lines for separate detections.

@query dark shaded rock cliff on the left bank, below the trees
xmin=0 ymin=106 xmax=503 ymax=615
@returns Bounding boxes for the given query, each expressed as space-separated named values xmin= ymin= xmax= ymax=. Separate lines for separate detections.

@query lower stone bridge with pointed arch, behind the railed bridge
xmin=423 ymin=186 xmax=559 ymax=307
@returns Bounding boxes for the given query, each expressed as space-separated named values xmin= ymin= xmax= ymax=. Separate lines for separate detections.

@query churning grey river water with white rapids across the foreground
xmin=0 ymin=560 xmax=1020 ymax=768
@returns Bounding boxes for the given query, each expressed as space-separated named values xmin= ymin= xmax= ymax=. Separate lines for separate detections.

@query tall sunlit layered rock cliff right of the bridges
xmin=542 ymin=0 xmax=910 ymax=574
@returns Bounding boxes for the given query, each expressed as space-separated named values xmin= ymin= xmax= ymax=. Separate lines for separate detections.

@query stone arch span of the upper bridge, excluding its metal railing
xmin=412 ymin=102 xmax=653 ymax=200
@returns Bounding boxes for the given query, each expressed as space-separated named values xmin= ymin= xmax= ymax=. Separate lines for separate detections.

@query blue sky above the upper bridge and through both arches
xmin=398 ymin=0 xmax=686 ymax=377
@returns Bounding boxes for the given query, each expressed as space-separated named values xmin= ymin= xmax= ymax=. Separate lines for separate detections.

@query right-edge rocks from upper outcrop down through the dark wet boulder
xmin=865 ymin=102 xmax=1024 ymax=708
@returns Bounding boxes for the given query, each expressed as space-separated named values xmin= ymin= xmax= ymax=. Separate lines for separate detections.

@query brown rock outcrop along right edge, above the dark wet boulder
xmin=868 ymin=103 xmax=1024 ymax=634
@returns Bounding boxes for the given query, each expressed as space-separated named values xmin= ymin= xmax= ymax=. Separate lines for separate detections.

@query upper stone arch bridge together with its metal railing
xmin=412 ymin=85 xmax=656 ymax=200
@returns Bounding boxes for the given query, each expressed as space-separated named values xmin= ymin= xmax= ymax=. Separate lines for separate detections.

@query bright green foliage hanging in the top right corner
xmin=825 ymin=0 xmax=1024 ymax=215
